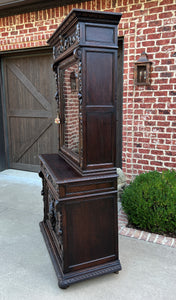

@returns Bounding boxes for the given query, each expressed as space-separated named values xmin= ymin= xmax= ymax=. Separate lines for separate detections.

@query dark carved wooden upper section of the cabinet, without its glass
xmin=48 ymin=10 xmax=121 ymax=176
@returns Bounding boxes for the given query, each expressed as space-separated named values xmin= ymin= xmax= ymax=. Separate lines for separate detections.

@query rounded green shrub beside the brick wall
xmin=122 ymin=170 xmax=176 ymax=236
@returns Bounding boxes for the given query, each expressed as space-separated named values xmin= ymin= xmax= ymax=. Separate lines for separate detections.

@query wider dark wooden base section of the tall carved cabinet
xmin=40 ymin=155 xmax=121 ymax=288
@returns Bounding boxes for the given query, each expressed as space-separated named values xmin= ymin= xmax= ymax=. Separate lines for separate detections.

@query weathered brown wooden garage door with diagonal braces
xmin=3 ymin=52 xmax=58 ymax=171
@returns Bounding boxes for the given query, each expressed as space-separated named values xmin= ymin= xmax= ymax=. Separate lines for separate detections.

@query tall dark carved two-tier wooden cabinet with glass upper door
xmin=40 ymin=9 xmax=121 ymax=288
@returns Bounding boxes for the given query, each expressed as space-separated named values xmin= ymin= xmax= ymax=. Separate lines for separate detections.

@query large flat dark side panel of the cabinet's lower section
xmin=65 ymin=195 xmax=117 ymax=271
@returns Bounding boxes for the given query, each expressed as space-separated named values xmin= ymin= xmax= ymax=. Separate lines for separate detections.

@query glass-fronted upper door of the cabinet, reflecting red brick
xmin=57 ymin=56 xmax=80 ymax=165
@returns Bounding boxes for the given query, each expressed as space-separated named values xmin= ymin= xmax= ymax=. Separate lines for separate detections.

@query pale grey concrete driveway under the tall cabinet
xmin=0 ymin=170 xmax=176 ymax=300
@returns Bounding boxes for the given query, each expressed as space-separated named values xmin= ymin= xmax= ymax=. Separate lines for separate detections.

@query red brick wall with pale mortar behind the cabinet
xmin=0 ymin=0 xmax=176 ymax=178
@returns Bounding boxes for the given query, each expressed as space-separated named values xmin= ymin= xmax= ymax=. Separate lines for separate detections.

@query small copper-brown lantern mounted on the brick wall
xmin=134 ymin=52 xmax=152 ymax=85
